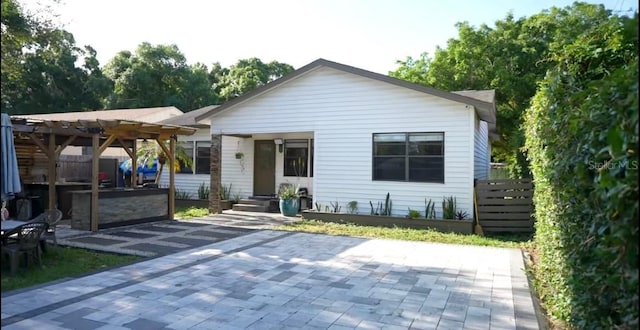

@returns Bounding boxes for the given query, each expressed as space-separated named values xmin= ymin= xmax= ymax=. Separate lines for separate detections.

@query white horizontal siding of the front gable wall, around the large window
xmin=211 ymin=68 xmax=474 ymax=215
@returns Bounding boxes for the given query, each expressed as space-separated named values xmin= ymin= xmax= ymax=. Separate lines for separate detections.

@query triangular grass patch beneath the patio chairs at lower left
xmin=1 ymin=246 xmax=142 ymax=292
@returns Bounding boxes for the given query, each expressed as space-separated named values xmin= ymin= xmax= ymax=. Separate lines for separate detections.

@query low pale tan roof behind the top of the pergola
xmin=13 ymin=107 xmax=183 ymax=122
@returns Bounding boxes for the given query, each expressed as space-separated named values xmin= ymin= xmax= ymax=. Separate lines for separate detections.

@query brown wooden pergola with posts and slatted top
xmin=11 ymin=116 xmax=196 ymax=231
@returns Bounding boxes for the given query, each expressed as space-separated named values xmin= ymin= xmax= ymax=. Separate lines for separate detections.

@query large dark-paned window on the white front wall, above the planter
xmin=373 ymin=133 xmax=444 ymax=183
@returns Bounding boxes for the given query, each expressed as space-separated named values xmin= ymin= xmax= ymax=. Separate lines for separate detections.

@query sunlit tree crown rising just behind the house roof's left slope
xmin=217 ymin=57 xmax=293 ymax=101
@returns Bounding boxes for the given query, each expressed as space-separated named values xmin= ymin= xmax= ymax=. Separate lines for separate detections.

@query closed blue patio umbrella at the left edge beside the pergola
xmin=0 ymin=113 xmax=22 ymax=205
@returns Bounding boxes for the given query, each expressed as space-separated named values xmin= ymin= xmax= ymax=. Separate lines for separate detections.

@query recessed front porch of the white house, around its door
xmin=209 ymin=132 xmax=315 ymax=212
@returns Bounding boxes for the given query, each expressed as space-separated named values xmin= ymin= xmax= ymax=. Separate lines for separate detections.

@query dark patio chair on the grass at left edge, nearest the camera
xmin=2 ymin=222 xmax=49 ymax=275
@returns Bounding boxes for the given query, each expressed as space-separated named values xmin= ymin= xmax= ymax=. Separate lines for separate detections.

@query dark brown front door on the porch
xmin=253 ymin=140 xmax=276 ymax=196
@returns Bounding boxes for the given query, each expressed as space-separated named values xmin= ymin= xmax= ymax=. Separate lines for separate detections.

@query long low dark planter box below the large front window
xmin=302 ymin=211 xmax=473 ymax=234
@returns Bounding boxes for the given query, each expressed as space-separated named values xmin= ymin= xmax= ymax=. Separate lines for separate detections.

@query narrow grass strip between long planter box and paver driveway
xmin=275 ymin=220 xmax=532 ymax=248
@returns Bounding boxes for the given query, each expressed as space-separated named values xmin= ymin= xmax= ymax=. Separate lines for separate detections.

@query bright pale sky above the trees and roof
xmin=25 ymin=0 xmax=638 ymax=74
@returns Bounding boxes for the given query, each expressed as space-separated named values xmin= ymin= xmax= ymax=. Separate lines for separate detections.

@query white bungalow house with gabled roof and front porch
xmin=193 ymin=59 xmax=496 ymax=217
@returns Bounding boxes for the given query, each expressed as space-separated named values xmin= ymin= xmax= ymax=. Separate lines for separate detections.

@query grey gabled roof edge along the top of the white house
xmin=195 ymin=58 xmax=496 ymax=131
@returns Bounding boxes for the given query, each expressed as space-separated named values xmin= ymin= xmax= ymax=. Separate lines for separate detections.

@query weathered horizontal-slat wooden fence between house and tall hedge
xmin=475 ymin=179 xmax=533 ymax=232
